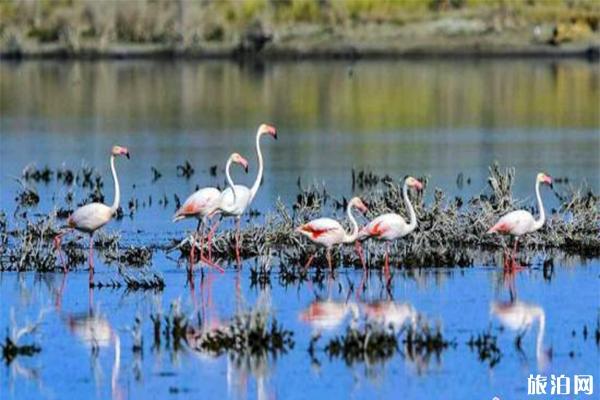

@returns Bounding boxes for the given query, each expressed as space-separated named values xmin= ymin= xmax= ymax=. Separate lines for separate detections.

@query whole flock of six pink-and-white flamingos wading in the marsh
xmin=54 ymin=124 xmax=552 ymax=285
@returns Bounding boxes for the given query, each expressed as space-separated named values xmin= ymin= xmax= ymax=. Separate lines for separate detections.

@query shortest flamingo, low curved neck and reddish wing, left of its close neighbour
xmin=296 ymin=197 xmax=368 ymax=271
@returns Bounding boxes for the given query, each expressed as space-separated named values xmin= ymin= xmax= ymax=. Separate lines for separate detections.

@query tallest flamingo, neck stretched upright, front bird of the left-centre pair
xmin=212 ymin=124 xmax=277 ymax=265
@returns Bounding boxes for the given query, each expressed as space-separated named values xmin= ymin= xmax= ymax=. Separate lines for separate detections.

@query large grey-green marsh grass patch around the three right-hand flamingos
xmin=179 ymin=164 xmax=600 ymax=268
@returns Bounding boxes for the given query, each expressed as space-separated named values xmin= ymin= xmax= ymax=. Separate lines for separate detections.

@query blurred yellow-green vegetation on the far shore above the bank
xmin=0 ymin=0 xmax=600 ymax=56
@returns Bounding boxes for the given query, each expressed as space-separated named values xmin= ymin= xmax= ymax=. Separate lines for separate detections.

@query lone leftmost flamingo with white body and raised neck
xmin=54 ymin=146 xmax=129 ymax=286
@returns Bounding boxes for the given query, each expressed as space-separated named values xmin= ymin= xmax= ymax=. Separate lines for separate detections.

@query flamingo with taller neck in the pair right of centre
xmin=358 ymin=176 xmax=423 ymax=276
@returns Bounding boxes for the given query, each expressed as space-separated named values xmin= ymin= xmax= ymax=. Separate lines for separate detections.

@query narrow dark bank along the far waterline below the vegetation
xmin=0 ymin=41 xmax=600 ymax=61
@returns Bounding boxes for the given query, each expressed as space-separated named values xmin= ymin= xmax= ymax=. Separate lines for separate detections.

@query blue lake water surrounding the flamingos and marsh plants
xmin=0 ymin=60 xmax=600 ymax=399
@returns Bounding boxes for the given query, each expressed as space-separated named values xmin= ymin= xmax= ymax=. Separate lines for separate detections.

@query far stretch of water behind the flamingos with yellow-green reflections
xmin=0 ymin=60 xmax=600 ymax=222
